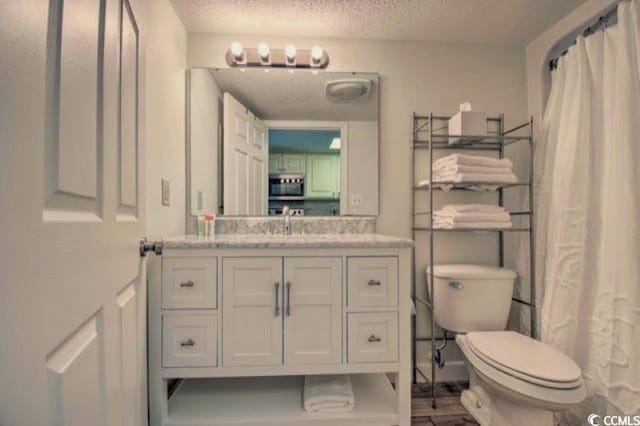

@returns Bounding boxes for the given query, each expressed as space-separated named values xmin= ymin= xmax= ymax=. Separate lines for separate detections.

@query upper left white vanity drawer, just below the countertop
xmin=162 ymin=257 xmax=218 ymax=309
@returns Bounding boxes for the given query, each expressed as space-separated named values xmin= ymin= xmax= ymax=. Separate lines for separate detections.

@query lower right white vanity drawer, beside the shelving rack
xmin=347 ymin=312 xmax=398 ymax=363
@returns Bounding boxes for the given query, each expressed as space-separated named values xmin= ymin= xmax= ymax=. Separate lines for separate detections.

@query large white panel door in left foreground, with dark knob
xmin=0 ymin=0 xmax=147 ymax=426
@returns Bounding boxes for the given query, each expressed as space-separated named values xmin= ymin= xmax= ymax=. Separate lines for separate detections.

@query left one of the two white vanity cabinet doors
xmin=222 ymin=257 xmax=282 ymax=366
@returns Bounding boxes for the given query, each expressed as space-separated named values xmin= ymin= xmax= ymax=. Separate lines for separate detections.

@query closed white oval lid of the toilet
xmin=467 ymin=331 xmax=582 ymax=387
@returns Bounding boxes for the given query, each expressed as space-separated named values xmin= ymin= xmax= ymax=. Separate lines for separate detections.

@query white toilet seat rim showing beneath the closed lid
xmin=456 ymin=332 xmax=586 ymax=411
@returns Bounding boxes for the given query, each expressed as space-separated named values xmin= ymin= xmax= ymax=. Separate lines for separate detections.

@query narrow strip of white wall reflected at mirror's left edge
xmin=189 ymin=69 xmax=222 ymax=220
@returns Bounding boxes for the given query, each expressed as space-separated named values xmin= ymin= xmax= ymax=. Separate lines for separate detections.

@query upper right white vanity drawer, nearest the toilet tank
xmin=347 ymin=256 xmax=398 ymax=307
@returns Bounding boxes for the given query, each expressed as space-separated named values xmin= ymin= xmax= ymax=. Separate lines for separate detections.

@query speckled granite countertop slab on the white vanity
xmin=163 ymin=233 xmax=413 ymax=249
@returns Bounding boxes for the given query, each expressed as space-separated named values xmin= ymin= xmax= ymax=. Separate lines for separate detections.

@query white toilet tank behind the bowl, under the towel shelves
xmin=427 ymin=265 xmax=516 ymax=333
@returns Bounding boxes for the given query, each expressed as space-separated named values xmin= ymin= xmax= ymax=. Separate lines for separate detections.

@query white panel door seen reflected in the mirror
xmin=223 ymin=93 xmax=269 ymax=215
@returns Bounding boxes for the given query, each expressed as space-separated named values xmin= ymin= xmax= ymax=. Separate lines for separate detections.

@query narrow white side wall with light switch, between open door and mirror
xmin=145 ymin=0 xmax=187 ymax=239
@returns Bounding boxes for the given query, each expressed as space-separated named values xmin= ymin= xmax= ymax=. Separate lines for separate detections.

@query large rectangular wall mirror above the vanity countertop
xmin=187 ymin=69 xmax=379 ymax=220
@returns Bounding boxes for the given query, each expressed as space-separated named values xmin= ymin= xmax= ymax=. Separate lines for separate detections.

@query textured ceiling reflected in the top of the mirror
xmin=211 ymin=69 xmax=378 ymax=121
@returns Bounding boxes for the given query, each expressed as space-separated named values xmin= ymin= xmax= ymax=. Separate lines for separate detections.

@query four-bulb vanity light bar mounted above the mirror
xmin=226 ymin=41 xmax=329 ymax=70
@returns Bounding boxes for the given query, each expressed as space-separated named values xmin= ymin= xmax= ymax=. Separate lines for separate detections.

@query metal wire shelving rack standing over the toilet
xmin=411 ymin=113 xmax=536 ymax=409
